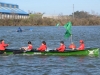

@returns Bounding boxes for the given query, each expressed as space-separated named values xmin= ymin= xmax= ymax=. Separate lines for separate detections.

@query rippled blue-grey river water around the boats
xmin=0 ymin=26 xmax=100 ymax=75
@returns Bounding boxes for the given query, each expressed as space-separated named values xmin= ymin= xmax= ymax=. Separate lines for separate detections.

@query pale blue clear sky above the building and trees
xmin=0 ymin=0 xmax=100 ymax=15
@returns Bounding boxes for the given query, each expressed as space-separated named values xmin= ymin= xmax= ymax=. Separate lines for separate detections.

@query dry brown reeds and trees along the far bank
xmin=0 ymin=11 xmax=100 ymax=26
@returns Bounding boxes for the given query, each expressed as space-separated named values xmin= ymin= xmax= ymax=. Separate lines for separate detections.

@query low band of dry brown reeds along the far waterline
xmin=0 ymin=17 xmax=100 ymax=26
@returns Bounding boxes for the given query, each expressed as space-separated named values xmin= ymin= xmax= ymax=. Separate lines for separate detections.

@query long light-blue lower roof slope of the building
xmin=0 ymin=7 xmax=28 ymax=15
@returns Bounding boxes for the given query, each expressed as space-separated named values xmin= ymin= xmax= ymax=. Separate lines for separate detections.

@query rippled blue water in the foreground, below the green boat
xmin=0 ymin=55 xmax=100 ymax=75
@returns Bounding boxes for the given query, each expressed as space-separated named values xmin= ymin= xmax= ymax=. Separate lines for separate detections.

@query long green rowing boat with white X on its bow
xmin=1 ymin=48 xmax=99 ymax=56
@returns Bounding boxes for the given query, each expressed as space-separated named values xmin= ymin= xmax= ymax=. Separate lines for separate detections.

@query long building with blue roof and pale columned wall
xmin=0 ymin=2 xmax=29 ymax=19
